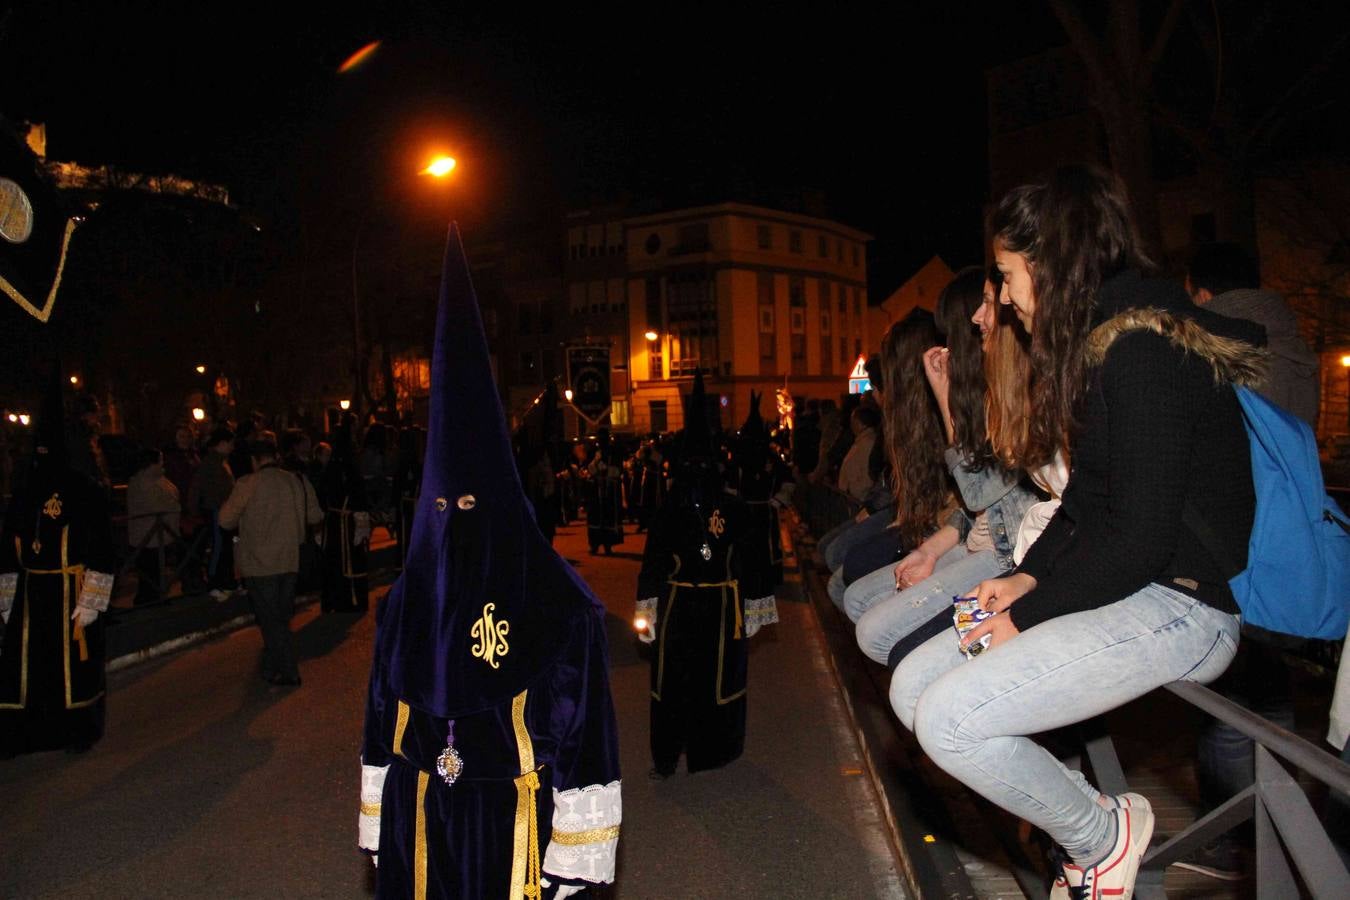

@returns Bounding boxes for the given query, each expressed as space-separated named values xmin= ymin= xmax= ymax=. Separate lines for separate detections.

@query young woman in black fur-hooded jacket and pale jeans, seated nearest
xmin=891 ymin=167 xmax=1264 ymax=900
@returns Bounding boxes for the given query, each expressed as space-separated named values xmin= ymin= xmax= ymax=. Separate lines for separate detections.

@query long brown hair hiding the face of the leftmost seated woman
xmin=882 ymin=309 xmax=950 ymax=548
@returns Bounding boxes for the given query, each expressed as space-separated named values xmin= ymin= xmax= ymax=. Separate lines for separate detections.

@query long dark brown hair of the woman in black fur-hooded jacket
xmin=988 ymin=166 xmax=1148 ymax=470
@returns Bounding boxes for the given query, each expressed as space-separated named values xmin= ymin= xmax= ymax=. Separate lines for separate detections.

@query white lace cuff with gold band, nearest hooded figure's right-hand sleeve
xmin=543 ymin=781 xmax=624 ymax=884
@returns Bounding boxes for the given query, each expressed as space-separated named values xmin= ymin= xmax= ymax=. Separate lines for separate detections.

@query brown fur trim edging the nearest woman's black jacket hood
xmin=1087 ymin=306 xmax=1270 ymax=387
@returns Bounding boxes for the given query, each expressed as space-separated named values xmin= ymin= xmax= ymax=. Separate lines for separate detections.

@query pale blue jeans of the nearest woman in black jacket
xmin=891 ymin=584 xmax=1239 ymax=864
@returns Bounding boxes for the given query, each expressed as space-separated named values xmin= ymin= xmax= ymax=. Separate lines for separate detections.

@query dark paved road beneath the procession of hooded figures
xmin=0 ymin=528 xmax=900 ymax=900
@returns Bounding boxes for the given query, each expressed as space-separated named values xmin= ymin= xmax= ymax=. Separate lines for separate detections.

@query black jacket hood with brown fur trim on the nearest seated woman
xmin=1087 ymin=270 xmax=1270 ymax=387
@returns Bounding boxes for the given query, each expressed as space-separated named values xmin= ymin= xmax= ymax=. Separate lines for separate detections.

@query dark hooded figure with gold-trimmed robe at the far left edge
xmin=0 ymin=364 xmax=113 ymax=756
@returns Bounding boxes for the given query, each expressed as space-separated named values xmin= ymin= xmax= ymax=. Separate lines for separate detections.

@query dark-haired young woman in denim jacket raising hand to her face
xmin=844 ymin=267 xmax=1037 ymax=664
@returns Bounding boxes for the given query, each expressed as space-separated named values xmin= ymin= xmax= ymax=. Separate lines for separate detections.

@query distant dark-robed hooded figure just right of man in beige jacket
xmin=319 ymin=414 xmax=370 ymax=613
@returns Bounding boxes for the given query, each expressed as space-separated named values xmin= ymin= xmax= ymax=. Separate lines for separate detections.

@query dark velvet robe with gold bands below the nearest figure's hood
xmin=360 ymin=609 xmax=622 ymax=900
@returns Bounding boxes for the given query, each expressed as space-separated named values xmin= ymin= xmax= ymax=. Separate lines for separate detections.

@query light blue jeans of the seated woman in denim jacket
xmin=844 ymin=544 xmax=1007 ymax=665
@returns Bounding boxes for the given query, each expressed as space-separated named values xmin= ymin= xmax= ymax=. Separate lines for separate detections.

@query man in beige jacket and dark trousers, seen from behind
xmin=220 ymin=432 xmax=323 ymax=685
